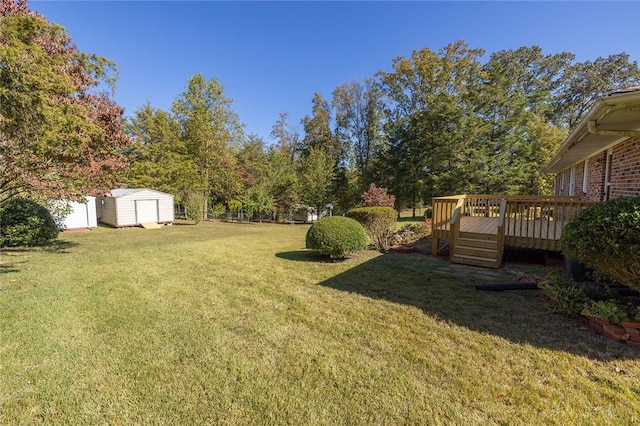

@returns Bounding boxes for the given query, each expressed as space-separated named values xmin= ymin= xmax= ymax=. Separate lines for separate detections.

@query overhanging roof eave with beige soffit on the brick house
xmin=546 ymin=86 xmax=640 ymax=173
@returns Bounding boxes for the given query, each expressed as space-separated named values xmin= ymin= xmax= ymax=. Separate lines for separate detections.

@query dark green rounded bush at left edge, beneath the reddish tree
xmin=0 ymin=198 xmax=60 ymax=247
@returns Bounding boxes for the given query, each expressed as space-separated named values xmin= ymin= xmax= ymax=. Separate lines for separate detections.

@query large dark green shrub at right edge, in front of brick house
xmin=562 ymin=197 xmax=640 ymax=290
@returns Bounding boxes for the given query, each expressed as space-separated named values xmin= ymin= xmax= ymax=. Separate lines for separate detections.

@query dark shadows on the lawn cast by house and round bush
xmin=302 ymin=252 xmax=640 ymax=360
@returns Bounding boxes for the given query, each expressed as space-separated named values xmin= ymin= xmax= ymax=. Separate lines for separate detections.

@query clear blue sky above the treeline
xmin=30 ymin=1 xmax=640 ymax=142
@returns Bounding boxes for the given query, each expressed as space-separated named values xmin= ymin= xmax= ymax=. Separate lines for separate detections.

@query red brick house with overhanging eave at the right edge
xmin=547 ymin=86 xmax=640 ymax=202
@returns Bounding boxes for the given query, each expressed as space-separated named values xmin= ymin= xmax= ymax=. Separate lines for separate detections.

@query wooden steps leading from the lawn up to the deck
xmin=451 ymin=231 xmax=500 ymax=268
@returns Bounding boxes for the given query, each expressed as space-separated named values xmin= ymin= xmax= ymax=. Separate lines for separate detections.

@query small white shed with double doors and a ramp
xmin=96 ymin=188 xmax=174 ymax=228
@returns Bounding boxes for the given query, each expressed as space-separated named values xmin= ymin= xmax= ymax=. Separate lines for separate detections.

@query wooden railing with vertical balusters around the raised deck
xmin=432 ymin=195 xmax=590 ymax=253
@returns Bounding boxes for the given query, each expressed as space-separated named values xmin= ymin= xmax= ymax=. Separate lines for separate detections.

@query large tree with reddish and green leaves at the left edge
xmin=0 ymin=0 xmax=131 ymax=204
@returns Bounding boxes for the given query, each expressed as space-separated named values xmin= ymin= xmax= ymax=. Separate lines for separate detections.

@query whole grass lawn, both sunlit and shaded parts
xmin=0 ymin=223 xmax=640 ymax=425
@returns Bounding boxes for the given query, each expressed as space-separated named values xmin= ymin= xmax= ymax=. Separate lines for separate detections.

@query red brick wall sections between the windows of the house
xmin=555 ymin=138 xmax=640 ymax=201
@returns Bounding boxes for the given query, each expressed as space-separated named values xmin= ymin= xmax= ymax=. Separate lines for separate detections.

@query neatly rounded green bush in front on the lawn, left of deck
xmin=306 ymin=216 xmax=367 ymax=259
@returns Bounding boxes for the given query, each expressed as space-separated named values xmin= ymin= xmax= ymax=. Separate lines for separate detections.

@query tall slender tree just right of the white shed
xmin=172 ymin=74 xmax=242 ymax=218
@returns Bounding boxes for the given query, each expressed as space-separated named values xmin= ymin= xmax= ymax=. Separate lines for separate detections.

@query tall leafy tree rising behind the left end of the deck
xmin=378 ymin=42 xmax=484 ymax=208
